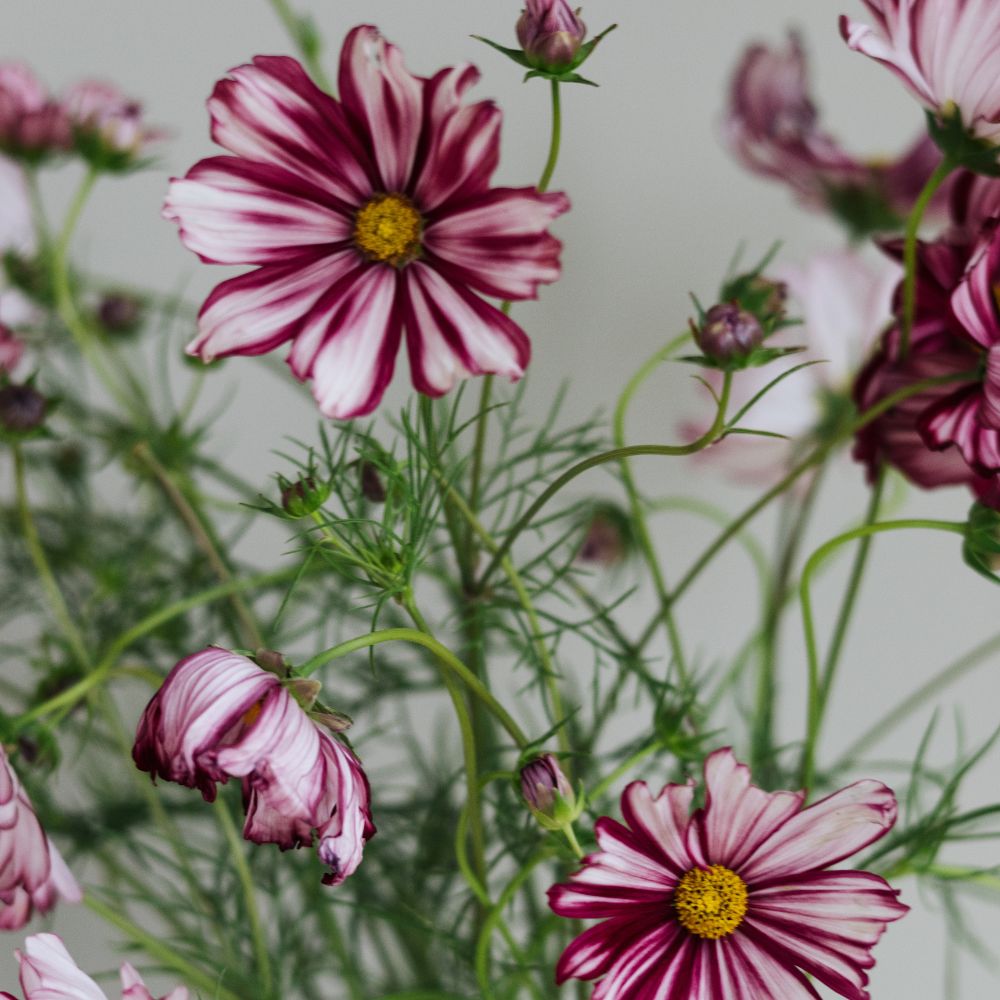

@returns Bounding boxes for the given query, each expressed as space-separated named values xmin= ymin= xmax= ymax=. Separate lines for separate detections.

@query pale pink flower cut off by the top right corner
xmin=840 ymin=0 xmax=1000 ymax=144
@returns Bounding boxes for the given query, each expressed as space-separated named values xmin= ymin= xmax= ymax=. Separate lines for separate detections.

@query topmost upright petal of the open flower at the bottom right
xmin=689 ymin=747 xmax=804 ymax=881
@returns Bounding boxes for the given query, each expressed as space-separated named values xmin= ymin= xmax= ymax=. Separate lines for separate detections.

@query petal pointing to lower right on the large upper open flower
xmin=403 ymin=261 xmax=531 ymax=396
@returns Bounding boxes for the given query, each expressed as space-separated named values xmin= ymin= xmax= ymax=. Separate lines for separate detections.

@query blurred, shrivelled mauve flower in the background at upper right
xmin=724 ymin=32 xmax=946 ymax=236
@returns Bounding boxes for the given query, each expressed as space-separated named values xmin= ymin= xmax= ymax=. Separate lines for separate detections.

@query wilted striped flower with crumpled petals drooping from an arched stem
xmin=132 ymin=647 xmax=375 ymax=885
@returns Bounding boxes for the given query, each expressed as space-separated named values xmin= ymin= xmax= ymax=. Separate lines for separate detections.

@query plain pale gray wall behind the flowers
xmin=0 ymin=0 xmax=1000 ymax=1000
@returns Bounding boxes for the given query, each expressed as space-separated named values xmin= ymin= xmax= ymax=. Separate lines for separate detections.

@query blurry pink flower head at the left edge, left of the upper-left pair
xmin=0 ymin=63 xmax=70 ymax=163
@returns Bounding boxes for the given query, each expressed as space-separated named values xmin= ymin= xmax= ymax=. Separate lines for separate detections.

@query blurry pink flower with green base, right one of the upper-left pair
xmin=64 ymin=80 xmax=158 ymax=172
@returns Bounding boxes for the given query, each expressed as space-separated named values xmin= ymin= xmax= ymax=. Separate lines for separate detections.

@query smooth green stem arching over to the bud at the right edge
xmin=799 ymin=518 xmax=965 ymax=790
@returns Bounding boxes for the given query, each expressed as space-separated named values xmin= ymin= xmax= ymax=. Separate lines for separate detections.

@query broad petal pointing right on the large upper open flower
xmin=424 ymin=188 xmax=569 ymax=299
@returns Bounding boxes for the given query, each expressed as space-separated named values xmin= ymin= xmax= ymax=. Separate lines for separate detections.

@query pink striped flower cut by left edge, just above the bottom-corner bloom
xmin=0 ymin=746 xmax=83 ymax=931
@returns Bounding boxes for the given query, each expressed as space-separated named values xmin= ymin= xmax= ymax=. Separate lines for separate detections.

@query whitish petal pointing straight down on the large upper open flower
xmin=296 ymin=265 xmax=402 ymax=420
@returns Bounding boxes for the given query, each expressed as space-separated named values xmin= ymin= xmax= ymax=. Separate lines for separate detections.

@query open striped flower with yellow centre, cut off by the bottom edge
xmin=549 ymin=749 xmax=908 ymax=1000
